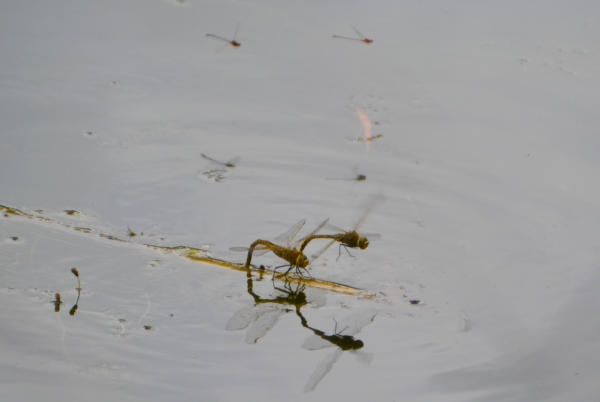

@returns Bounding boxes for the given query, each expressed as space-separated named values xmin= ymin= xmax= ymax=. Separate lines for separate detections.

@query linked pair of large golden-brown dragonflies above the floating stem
xmin=230 ymin=199 xmax=381 ymax=278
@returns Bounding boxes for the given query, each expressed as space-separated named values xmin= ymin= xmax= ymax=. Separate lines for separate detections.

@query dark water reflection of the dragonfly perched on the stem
xmin=225 ymin=278 xmax=327 ymax=344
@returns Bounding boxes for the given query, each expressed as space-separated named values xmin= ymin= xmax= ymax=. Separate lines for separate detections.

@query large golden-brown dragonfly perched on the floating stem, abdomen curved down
xmin=230 ymin=219 xmax=329 ymax=279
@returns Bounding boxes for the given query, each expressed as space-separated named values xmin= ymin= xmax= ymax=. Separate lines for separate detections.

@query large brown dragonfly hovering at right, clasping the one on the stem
xmin=300 ymin=194 xmax=383 ymax=261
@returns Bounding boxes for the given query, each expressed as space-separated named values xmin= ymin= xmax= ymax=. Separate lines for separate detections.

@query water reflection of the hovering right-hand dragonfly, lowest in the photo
xmin=297 ymin=310 xmax=379 ymax=393
